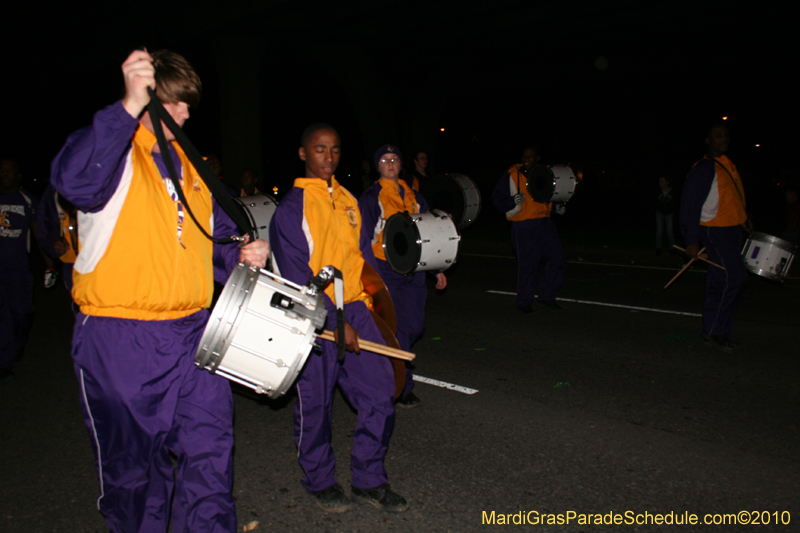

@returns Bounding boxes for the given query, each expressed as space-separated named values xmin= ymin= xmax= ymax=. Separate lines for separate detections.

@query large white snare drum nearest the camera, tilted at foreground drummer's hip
xmin=195 ymin=264 xmax=327 ymax=398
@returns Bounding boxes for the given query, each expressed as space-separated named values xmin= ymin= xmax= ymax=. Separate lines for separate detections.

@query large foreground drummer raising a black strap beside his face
xmin=51 ymin=50 xmax=268 ymax=532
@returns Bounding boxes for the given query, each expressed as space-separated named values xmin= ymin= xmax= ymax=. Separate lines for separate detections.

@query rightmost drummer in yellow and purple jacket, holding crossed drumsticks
xmin=680 ymin=124 xmax=752 ymax=352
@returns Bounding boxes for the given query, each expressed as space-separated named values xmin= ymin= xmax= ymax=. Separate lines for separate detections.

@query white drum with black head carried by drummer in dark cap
xmin=383 ymin=213 xmax=461 ymax=275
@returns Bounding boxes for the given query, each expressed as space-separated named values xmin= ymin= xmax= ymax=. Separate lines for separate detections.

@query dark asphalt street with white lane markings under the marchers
xmin=0 ymin=217 xmax=800 ymax=532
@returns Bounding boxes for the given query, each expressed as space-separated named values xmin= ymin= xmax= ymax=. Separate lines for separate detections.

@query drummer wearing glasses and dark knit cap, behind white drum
xmin=358 ymin=144 xmax=447 ymax=408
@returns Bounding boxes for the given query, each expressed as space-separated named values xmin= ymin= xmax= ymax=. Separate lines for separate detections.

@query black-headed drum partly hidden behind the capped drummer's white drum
xmin=422 ymin=174 xmax=481 ymax=230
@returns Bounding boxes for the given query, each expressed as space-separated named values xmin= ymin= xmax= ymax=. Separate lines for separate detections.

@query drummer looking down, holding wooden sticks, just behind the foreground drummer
xmin=269 ymin=123 xmax=408 ymax=513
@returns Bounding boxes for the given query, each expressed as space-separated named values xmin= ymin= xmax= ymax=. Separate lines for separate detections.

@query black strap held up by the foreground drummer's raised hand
xmin=147 ymin=87 xmax=254 ymax=244
